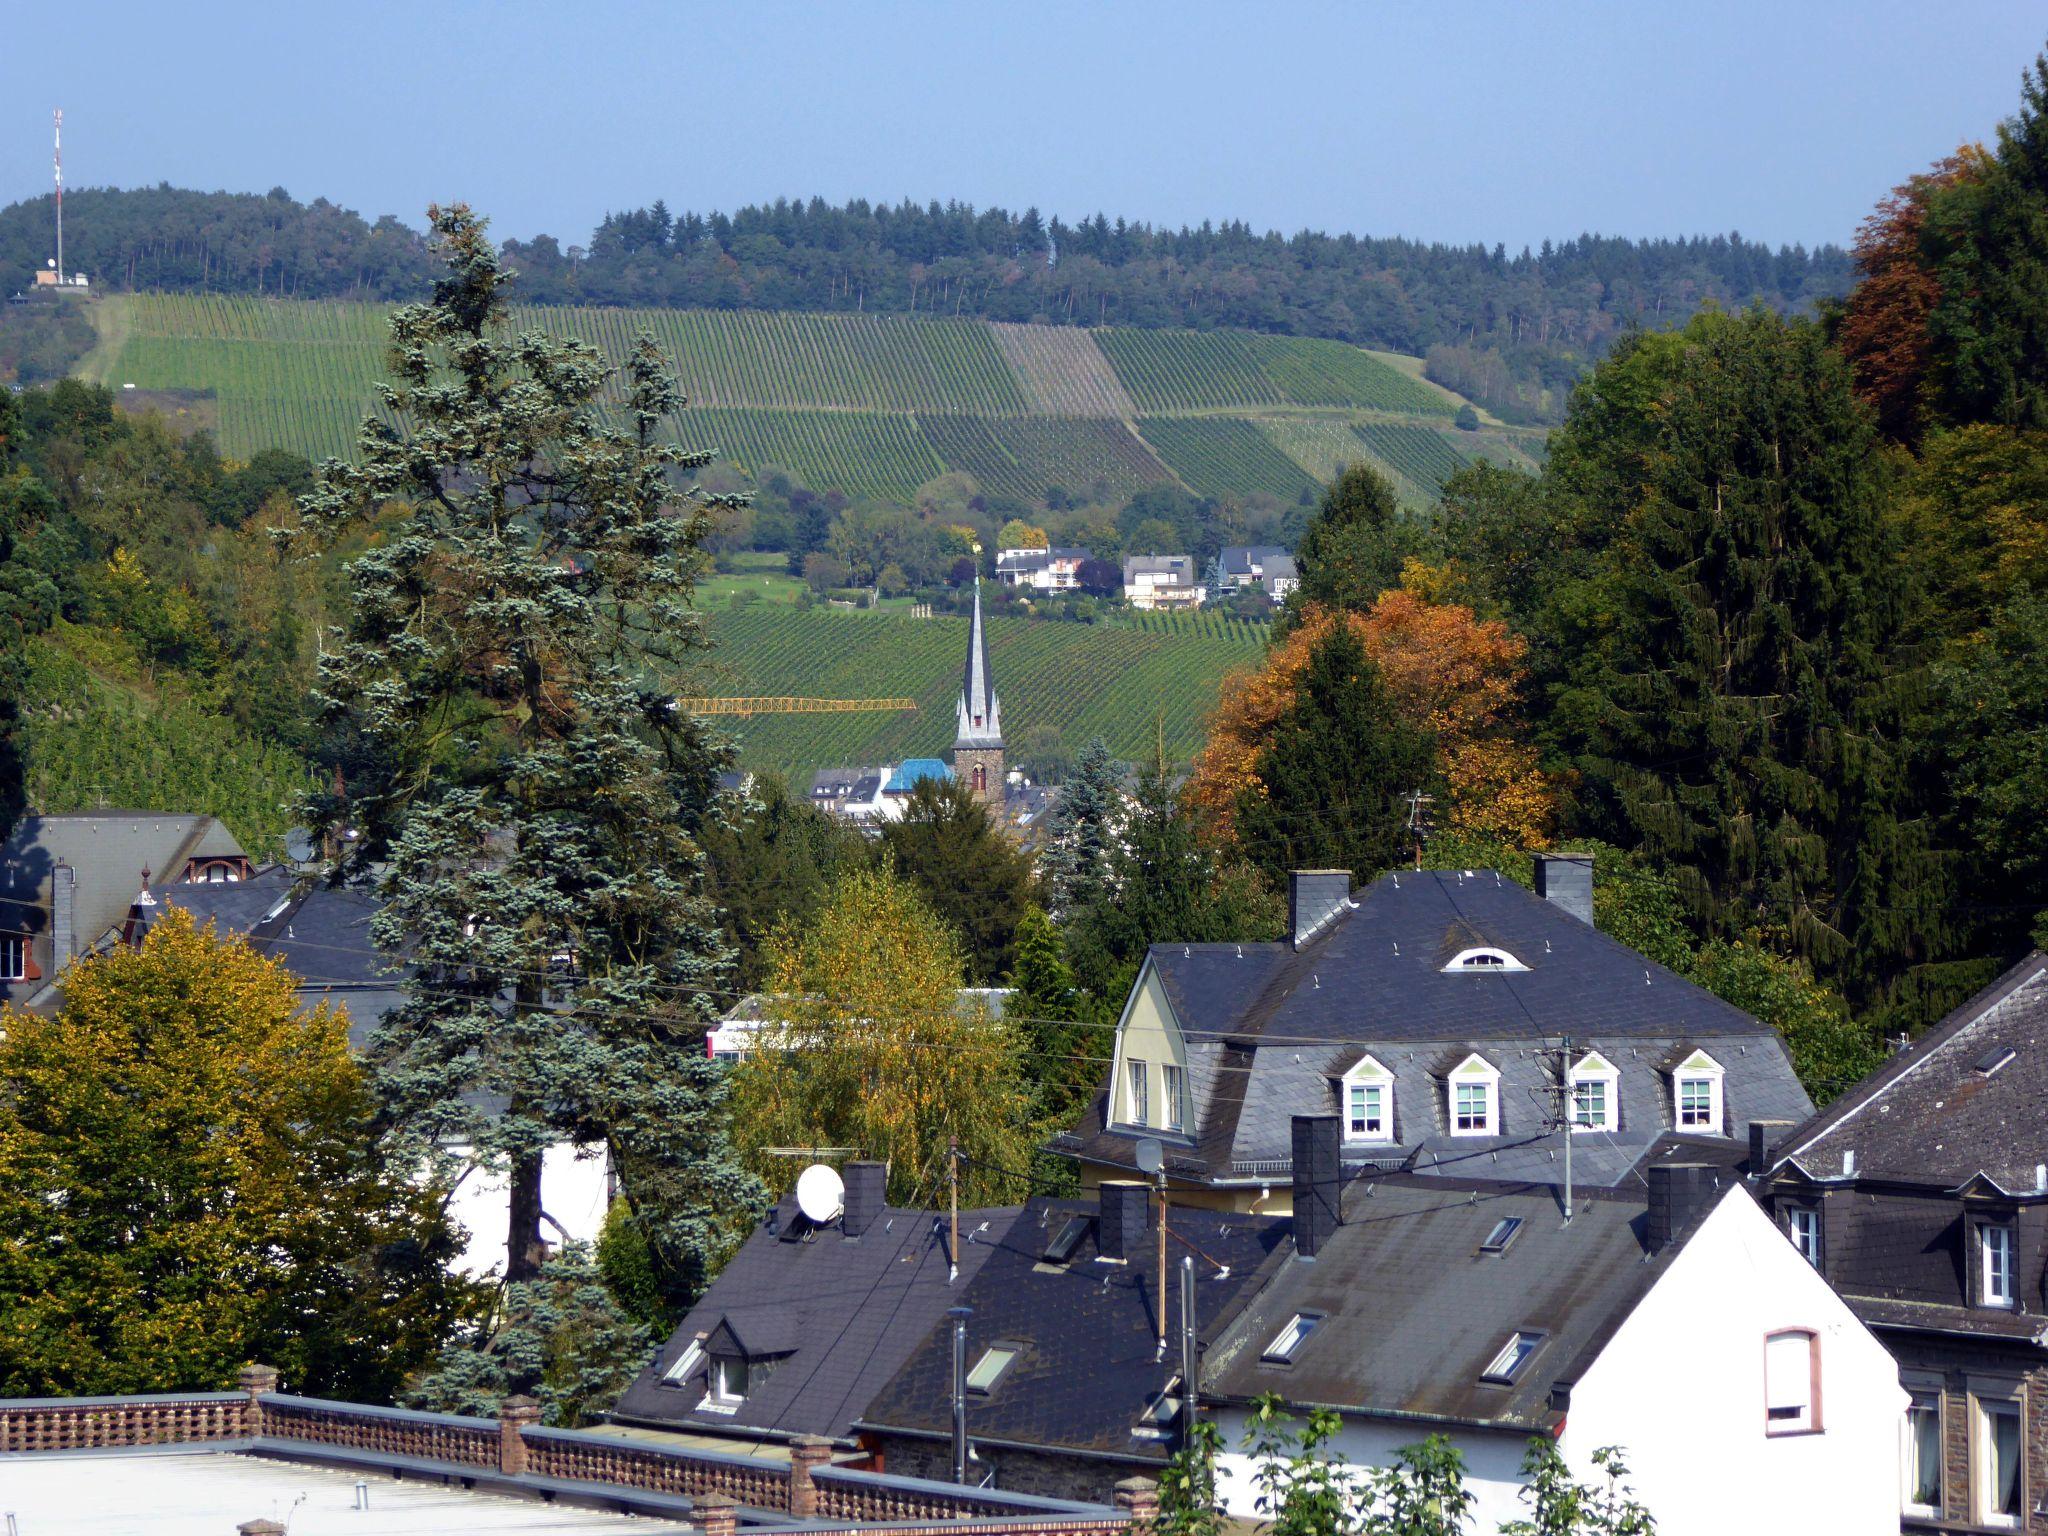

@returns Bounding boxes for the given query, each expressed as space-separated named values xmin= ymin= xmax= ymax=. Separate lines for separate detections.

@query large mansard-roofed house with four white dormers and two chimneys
xmin=1055 ymin=868 xmax=1812 ymax=1214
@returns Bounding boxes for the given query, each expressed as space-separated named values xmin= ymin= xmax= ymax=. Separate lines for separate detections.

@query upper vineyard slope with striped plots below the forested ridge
xmin=82 ymin=295 xmax=1540 ymax=514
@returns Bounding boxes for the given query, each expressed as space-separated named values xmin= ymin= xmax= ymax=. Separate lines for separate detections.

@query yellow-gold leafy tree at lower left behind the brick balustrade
xmin=0 ymin=907 xmax=469 ymax=1401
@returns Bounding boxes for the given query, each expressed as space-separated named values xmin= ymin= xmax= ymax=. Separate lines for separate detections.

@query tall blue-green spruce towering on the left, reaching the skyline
xmin=303 ymin=205 xmax=760 ymax=1288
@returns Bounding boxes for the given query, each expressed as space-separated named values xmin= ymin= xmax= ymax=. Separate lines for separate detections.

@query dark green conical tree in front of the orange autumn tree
xmin=1237 ymin=625 xmax=1436 ymax=885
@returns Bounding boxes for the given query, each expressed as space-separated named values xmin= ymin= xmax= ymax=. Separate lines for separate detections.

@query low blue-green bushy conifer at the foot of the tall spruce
xmin=406 ymin=1243 xmax=655 ymax=1430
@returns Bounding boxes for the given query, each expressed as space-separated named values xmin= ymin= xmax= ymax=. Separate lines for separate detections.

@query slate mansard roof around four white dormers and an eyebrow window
xmin=1063 ymin=870 xmax=1812 ymax=1186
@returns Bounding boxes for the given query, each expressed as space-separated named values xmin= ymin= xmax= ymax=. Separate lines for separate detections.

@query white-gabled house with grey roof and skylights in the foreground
xmin=1202 ymin=1116 xmax=1907 ymax=1536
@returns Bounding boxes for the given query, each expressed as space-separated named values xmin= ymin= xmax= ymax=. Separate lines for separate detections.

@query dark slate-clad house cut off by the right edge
xmin=1757 ymin=950 xmax=2048 ymax=1532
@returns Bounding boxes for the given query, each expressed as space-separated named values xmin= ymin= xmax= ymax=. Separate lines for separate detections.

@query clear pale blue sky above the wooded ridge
xmin=0 ymin=0 xmax=2048 ymax=250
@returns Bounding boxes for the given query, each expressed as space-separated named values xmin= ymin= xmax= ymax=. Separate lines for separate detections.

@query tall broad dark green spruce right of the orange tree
xmin=1552 ymin=311 xmax=1942 ymax=1001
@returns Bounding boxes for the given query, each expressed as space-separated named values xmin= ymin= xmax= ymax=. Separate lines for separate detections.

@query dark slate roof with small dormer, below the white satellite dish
xmin=614 ymin=1196 xmax=1016 ymax=1440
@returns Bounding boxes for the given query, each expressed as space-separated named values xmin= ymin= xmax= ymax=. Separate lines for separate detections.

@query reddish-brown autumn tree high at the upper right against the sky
xmin=1835 ymin=145 xmax=1985 ymax=442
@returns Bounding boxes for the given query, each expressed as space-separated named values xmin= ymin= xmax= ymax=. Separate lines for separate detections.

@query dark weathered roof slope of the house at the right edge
xmin=1776 ymin=950 xmax=2048 ymax=1194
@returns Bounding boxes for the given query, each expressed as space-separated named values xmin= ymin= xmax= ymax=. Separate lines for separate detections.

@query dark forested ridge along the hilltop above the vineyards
xmin=0 ymin=186 xmax=1853 ymax=424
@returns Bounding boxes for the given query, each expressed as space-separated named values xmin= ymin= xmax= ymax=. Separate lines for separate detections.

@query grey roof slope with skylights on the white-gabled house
xmin=1202 ymin=1182 xmax=1681 ymax=1432
